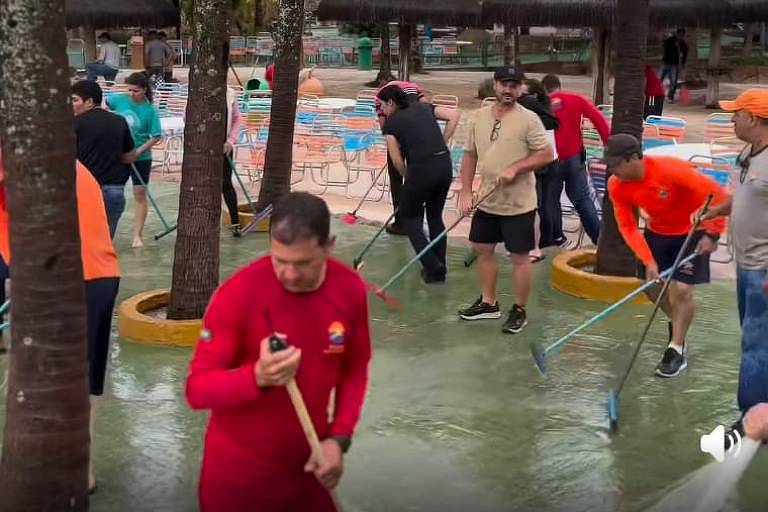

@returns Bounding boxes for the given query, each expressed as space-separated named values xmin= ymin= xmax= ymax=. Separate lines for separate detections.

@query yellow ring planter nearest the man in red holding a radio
xmin=117 ymin=290 xmax=202 ymax=347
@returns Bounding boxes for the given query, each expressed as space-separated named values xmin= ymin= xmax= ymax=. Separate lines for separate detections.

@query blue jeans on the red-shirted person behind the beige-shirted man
xmin=555 ymin=155 xmax=600 ymax=245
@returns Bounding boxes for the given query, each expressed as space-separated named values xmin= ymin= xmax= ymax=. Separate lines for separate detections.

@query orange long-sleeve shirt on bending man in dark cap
xmin=608 ymin=156 xmax=728 ymax=265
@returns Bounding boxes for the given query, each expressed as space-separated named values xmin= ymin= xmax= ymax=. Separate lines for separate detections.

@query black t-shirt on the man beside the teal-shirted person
xmin=75 ymin=108 xmax=134 ymax=186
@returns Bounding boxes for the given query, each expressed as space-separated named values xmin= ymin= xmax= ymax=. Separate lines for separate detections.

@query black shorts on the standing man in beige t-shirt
xmin=469 ymin=210 xmax=536 ymax=254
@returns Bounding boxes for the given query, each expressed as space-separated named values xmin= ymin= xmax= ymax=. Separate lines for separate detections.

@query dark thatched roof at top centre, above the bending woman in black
xmin=318 ymin=0 xmax=482 ymax=25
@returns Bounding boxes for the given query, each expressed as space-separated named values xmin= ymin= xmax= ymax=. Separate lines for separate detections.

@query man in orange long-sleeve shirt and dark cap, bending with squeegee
xmin=605 ymin=134 xmax=728 ymax=377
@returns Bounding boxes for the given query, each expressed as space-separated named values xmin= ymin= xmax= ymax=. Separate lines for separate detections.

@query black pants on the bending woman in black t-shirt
xmin=400 ymin=152 xmax=453 ymax=276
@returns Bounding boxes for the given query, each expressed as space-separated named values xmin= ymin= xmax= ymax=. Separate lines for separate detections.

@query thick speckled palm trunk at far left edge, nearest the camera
xmin=0 ymin=0 xmax=90 ymax=512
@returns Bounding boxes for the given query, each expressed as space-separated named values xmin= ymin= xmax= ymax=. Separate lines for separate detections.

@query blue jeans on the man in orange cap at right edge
xmin=736 ymin=267 xmax=768 ymax=412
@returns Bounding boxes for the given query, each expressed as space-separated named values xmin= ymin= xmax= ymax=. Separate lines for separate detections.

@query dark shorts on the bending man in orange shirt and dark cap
xmin=640 ymin=229 xmax=709 ymax=285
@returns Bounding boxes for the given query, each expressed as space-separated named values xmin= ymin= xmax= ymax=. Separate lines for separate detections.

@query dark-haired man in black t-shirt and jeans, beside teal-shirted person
xmin=72 ymin=80 xmax=136 ymax=238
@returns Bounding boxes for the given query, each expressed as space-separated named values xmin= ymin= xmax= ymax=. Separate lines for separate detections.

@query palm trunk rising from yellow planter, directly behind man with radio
xmin=168 ymin=0 xmax=231 ymax=320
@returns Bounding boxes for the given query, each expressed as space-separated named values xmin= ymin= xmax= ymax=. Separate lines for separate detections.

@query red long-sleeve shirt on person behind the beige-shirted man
xmin=552 ymin=91 xmax=610 ymax=160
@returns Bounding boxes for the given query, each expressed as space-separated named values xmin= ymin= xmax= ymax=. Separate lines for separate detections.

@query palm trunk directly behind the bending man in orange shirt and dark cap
xmin=596 ymin=0 xmax=650 ymax=276
